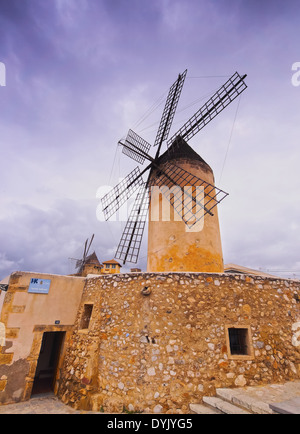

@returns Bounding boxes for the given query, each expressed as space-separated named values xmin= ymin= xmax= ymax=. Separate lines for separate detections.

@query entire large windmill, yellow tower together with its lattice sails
xmin=102 ymin=71 xmax=247 ymax=272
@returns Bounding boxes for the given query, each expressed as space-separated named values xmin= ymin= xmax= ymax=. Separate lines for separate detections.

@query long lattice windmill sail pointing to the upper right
xmin=167 ymin=72 xmax=247 ymax=147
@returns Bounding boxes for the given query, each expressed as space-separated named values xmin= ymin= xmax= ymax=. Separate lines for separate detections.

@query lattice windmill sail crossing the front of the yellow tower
xmin=150 ymin=162 xmax=228 ymax=228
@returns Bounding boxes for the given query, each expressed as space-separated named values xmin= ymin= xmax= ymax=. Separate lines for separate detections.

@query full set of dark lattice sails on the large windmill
xmin=101 ymin=70 xmax=247 ymax=264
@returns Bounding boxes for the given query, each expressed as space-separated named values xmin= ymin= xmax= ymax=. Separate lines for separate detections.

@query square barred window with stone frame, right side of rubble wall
xmin=226 ymin=326 xmax=253 ymax=360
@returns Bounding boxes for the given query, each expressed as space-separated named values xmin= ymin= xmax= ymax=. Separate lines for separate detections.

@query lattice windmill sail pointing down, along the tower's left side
xmin=115 ymin=184 xmax=150 ymax=263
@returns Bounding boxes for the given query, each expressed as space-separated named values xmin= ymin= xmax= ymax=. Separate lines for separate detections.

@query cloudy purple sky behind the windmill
xmin=0 ymin=0 xmax=300 ymax=279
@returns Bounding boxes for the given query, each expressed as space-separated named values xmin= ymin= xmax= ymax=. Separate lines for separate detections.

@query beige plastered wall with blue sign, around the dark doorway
xmin=0 ymin=272 xmax=85 ymax=404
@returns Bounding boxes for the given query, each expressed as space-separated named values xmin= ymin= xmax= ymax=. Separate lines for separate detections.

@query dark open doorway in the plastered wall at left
xmin=32 ymin=332 xmax=65 ymax=395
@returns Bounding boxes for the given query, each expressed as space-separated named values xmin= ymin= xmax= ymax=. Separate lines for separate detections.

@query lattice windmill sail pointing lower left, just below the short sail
xmin=101 ymin=167 xmax=143 ymax=220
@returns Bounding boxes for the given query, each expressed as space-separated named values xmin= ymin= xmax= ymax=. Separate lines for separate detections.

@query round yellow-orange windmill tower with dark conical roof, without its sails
xmin=147 ymin=136 xmax=226 ymax=272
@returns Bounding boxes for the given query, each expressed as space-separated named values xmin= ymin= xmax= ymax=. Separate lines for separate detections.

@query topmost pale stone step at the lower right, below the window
xmin=216 ymin=389 xmax=275 ymax=414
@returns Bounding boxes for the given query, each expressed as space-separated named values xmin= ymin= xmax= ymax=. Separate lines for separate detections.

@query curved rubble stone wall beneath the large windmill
xmin=59 ymin=273 xmax=300 ymax=413
